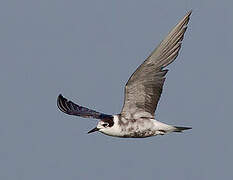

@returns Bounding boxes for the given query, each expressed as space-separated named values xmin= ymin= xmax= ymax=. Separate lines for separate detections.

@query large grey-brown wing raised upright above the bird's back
xmin=121 ymin=11 xmax=192 ymax=119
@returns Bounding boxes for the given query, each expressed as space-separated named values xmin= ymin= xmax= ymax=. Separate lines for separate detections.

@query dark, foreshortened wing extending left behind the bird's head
xmin=57 ymin=94 xmax=111 ymax=119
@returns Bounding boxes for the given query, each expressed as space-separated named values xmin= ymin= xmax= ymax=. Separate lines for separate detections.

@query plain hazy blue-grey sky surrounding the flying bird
xmin=0 ymin=0 xmax=233 ymax=180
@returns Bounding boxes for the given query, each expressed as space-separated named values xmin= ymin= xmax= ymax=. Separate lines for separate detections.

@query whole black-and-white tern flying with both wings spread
xmin=57 ymin=11 xmax=192 ymax=138
